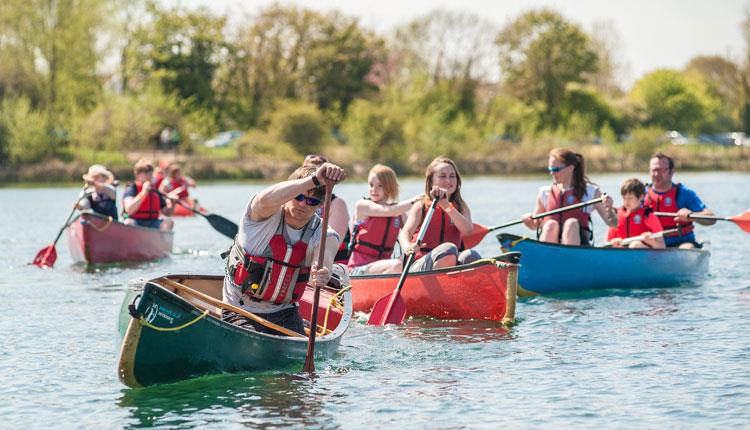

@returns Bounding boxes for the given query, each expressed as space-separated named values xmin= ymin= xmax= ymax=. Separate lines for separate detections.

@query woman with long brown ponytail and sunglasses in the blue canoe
xmin=523 ymin=148 xmax=617 ymax=245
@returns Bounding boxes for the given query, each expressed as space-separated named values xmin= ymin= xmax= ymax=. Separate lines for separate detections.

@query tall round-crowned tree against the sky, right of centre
xmin=496 ymin=9 xmax=597 ymax=127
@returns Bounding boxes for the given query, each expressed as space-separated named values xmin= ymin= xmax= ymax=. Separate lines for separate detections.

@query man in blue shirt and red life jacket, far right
xmin=644 ymin=152 xmax=716 ymax=248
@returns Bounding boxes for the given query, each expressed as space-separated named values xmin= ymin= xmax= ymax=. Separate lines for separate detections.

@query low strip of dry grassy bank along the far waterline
xmin=0 ymin=139 xmax=750 ymax=185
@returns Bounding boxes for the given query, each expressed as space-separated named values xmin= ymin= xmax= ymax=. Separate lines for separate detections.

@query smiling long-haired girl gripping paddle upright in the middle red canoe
xmin=398 ymin=157 xmax=480 ymax=272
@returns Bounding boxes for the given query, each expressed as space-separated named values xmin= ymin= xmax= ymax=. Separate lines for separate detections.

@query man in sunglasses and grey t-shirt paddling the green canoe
xmin=222 ymin=163 xmax=344 ymax=335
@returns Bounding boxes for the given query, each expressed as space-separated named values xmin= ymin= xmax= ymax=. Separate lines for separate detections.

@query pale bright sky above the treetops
xmin=175 ymin=0 xmax=750 ymax=85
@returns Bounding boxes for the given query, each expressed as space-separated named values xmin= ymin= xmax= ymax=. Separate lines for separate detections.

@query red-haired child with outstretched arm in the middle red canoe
xmin=349 ymin=164 xmax=423 ymax=275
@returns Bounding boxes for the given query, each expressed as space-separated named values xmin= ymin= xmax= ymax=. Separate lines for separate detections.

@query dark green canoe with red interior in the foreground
xmin=118 ymin=275 xmax=352 ymax=387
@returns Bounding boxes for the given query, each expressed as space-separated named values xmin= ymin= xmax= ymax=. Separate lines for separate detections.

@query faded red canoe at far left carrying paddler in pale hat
xmin=68 ymin=212 xmax=174 ymax=264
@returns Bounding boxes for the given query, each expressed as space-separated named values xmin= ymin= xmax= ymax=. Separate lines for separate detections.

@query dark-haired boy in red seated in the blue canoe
xmin=607 ymin=178 xmax=665 ymax=248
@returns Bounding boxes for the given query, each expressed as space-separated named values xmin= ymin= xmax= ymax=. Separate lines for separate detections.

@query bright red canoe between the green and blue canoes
xmin=351 ymin=252 xmax=520 ymax=322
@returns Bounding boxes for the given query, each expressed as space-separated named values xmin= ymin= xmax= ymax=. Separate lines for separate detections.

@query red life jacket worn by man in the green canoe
xmin=227 ymin=215 xmax=321 ymax=305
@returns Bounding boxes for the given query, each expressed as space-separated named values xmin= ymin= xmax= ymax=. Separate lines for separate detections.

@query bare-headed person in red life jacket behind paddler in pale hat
xmin=122 ymin=160 xmax=174 ymax=231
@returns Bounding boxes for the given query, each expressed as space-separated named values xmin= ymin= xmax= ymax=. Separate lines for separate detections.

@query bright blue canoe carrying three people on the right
xmin=497 ymin=233 xmax=711 ymax=294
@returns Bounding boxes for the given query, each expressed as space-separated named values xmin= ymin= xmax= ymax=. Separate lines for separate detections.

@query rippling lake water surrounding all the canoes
xmin=0 ymin=173 xmax=750 ymax=429
